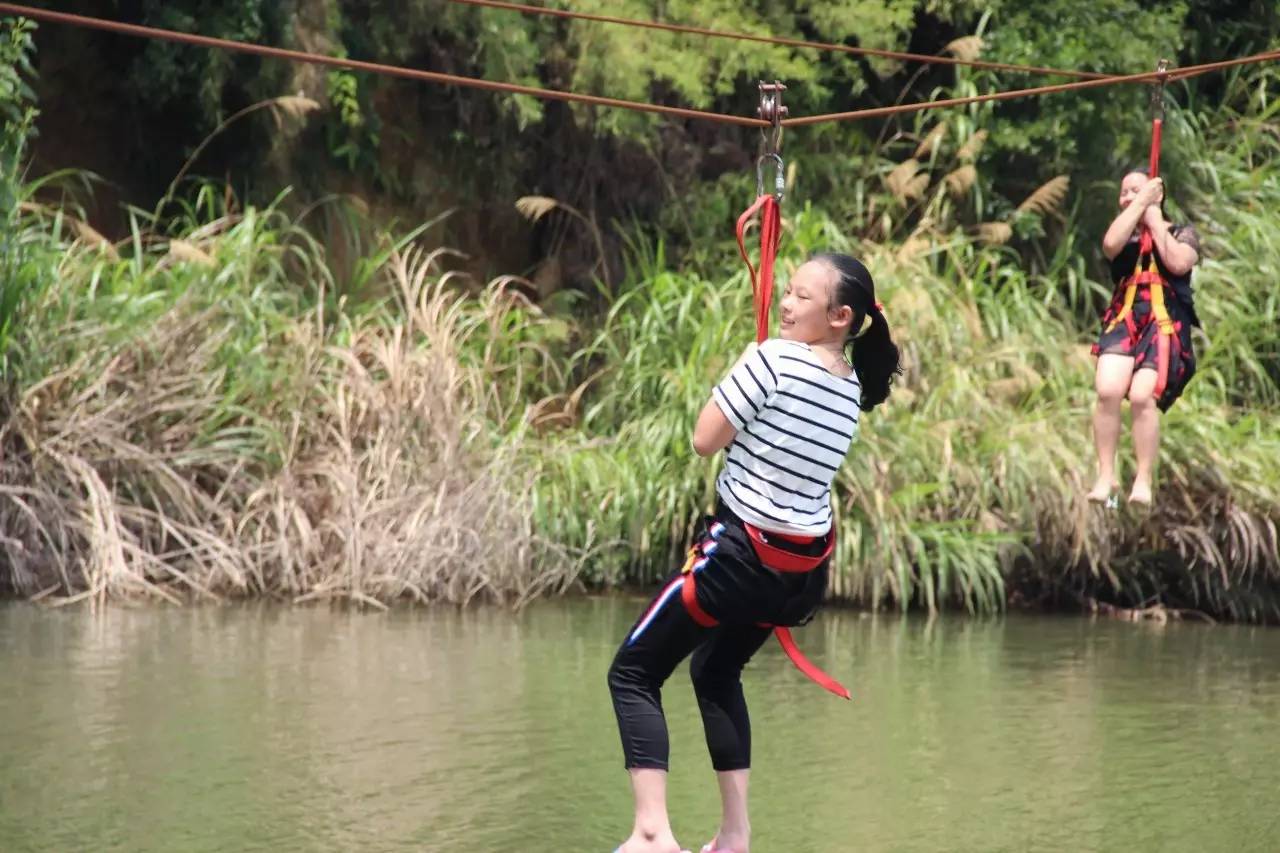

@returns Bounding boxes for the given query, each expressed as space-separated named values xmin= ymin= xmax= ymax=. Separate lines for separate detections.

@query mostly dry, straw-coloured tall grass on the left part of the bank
xmin=0 ymin=192 xmax=577 ymax=606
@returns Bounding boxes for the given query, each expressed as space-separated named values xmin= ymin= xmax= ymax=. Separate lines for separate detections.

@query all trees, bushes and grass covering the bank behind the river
xmin=0 ymin=6 xmax=1280 ymax=620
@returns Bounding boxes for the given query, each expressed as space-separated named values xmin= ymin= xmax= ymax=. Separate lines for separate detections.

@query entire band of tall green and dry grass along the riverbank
xmin=0 ymin=53 xmax=1280 ymax=620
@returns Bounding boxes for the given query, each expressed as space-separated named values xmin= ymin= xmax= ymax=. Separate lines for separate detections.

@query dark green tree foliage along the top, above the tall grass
xmin=67 ymin=0 xmax=1280 ymax=283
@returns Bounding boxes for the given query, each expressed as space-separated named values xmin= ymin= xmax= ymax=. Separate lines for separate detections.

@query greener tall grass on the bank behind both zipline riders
xmin=522 ymin=68 xmax=1280 ymax=620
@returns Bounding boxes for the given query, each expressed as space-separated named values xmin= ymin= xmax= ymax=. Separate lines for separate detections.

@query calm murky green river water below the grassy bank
xmin=0 ymin=597 xmax=1280 ymax=853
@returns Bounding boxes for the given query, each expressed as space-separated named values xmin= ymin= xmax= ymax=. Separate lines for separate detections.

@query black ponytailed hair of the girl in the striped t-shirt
xmin=810 ymin=252 xmax=902 ymax=411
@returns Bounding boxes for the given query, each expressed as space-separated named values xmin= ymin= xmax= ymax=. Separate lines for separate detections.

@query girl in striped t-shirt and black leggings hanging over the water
xmin=609 ymin=254 xmax=900 ymax=853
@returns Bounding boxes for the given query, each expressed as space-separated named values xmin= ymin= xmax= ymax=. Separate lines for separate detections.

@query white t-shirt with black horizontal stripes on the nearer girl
xmin=713 ymin=338 xmax=861 ymax=535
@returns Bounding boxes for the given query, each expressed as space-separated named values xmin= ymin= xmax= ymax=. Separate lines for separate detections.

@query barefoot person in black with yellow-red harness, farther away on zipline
xmin=1088 ymin=169 xmax=1199 ymax=505
